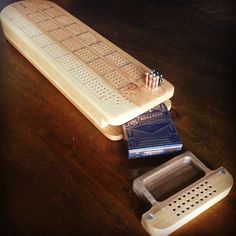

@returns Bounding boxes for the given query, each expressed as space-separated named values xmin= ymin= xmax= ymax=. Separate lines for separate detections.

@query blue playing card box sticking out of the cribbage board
xmin=123 ymin=104 xmax=183 ymax=159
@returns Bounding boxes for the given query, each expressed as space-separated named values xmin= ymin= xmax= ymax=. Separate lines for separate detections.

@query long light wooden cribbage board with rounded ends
xmin=1 ymin=1 xmax=174 ymax=140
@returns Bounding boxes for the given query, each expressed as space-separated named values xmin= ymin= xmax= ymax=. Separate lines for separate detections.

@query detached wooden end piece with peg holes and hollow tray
xmin=133 ymin=152 xmax=233 ymax=236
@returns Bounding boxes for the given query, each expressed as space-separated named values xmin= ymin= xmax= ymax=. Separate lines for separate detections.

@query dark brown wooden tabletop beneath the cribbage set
xmin=0 ymin=0 xmax=236 ymax=236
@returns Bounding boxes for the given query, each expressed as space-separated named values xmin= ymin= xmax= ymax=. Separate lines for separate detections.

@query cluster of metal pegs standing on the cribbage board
xmin=145 ymin=70 xmax=163 ymax=91
